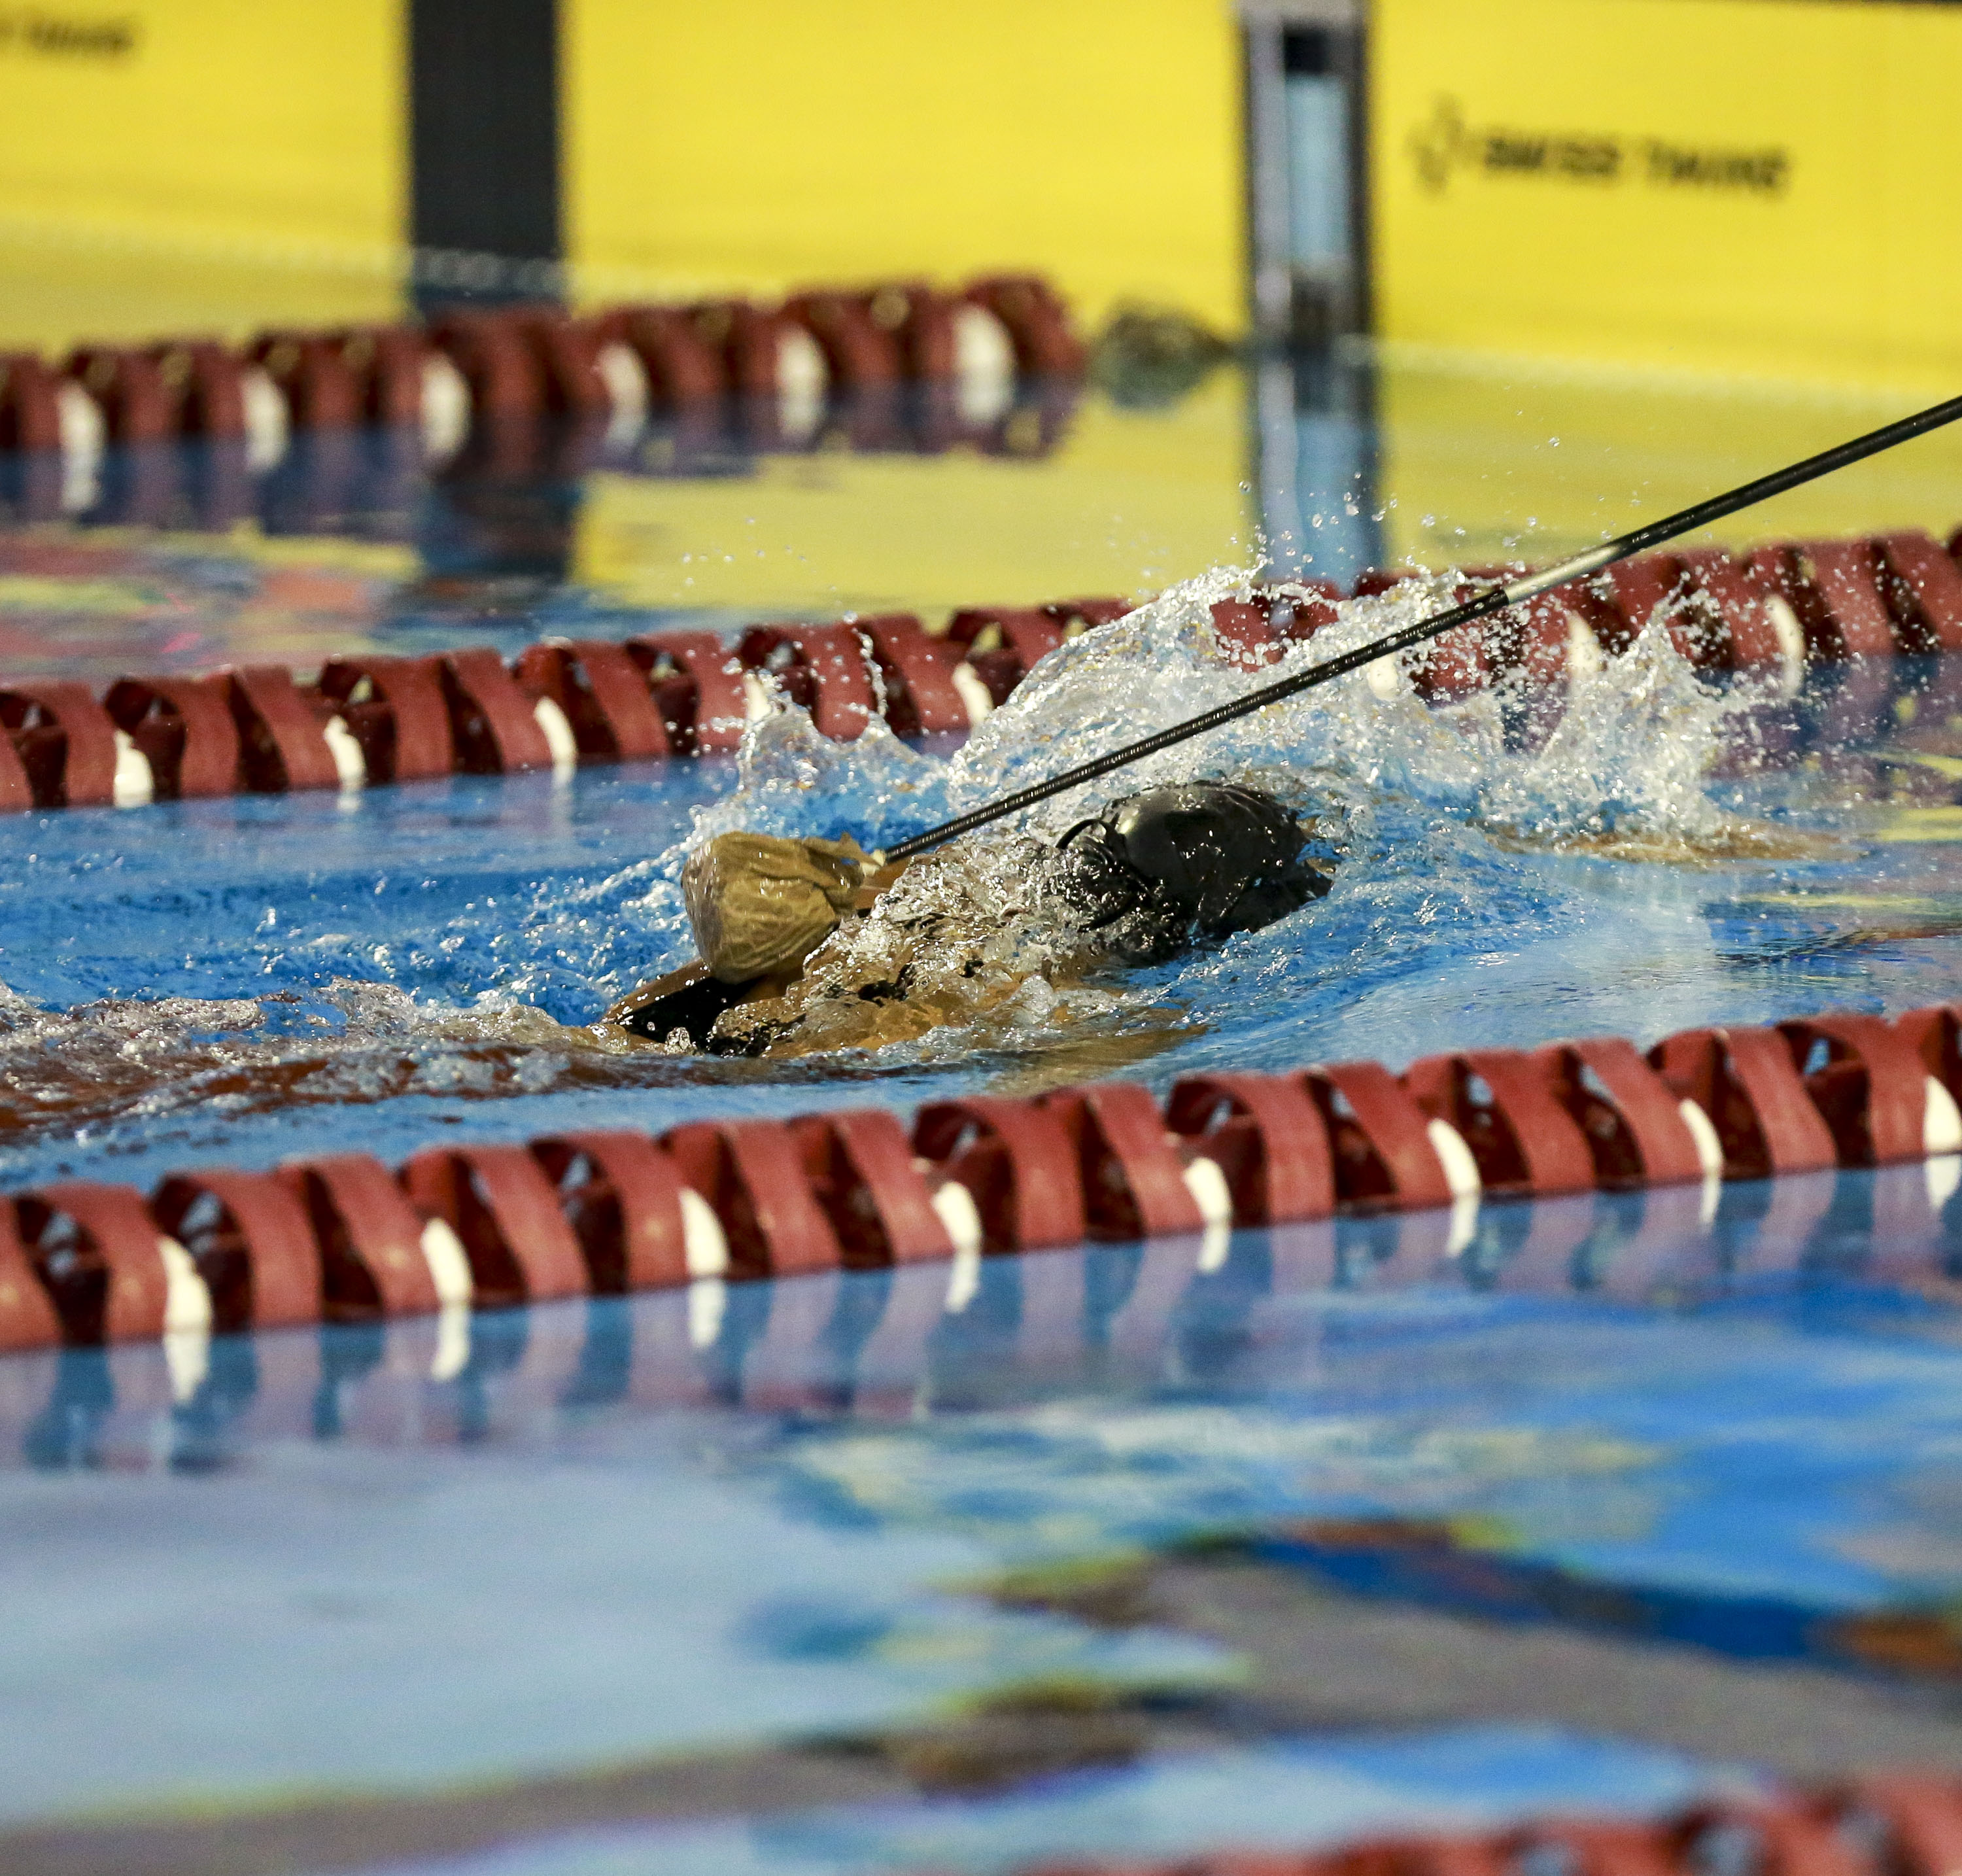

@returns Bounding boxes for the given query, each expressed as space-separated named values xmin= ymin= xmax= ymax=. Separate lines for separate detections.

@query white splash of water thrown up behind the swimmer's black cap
xmin=702 ymin=567 xmax=1760 ymax=858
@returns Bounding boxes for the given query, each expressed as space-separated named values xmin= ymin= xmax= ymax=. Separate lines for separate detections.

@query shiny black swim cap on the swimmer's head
xmin=1058 ymin=781 xmax=1328 ymax=964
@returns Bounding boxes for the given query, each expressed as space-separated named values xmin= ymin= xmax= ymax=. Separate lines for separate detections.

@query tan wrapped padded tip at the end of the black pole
xmin=681 ymin=834 xmax=873 ymax=983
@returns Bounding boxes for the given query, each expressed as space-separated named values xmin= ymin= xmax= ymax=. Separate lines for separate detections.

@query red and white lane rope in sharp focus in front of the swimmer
xmin=0 ymin=1003 xmax=1962 ymax=1348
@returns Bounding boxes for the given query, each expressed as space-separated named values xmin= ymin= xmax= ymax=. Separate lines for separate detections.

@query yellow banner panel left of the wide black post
xmin=0 ymin=0 xmax=408 ymax=347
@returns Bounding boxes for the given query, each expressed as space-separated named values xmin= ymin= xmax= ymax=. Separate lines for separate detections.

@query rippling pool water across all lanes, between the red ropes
xmin=0 ymin=359 xmax=1962 ymax=1870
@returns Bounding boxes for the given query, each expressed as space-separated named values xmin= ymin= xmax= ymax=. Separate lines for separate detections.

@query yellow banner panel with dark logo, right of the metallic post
xmin=1371 ymin=0 xmax=1962 ymax=392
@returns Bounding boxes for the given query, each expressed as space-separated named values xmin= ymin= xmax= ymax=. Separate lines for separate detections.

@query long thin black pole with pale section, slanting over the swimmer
xmin=885 ymin=396 xmax=1962 ymax=860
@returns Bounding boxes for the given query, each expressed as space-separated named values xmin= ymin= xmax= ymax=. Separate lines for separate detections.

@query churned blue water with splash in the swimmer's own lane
xmin=0 ymin=569 xmax=1962 ymax=1170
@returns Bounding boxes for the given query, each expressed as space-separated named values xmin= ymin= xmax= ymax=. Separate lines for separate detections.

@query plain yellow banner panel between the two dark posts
xmin=561 ymin=0 xmax=1246 ymax=332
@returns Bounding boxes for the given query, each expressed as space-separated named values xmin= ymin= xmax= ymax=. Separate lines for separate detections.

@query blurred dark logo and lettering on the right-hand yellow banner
xmin=1409 ymin=96 xmax=1791 ymax=196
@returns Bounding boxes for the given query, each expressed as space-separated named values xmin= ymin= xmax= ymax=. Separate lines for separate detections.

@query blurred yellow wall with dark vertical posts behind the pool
xmin=0 ymin=0 xmax=1962 ymax=400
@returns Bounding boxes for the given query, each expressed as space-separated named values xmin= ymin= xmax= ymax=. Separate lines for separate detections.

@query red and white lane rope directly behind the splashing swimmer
xmin=0 ymin=522 xmax=1962 ymax=812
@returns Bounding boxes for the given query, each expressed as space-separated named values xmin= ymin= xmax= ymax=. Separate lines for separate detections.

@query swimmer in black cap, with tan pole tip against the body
xmin=606 ymin=781 xmax=1330 ymax=1058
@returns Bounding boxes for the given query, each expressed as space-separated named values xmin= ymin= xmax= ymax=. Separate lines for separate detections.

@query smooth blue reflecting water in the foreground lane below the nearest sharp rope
xmin=0 ymin=1166 xmax=1962 ymax=1870
